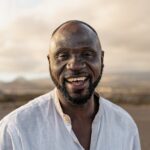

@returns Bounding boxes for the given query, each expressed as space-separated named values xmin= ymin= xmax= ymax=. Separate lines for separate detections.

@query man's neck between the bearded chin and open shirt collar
xmin=57 ymin=91 xmax=98 ymax=121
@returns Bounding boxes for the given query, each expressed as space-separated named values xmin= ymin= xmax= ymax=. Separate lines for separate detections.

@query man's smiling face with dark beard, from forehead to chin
xmin=49 ymin=25 xmax=102 ymax=105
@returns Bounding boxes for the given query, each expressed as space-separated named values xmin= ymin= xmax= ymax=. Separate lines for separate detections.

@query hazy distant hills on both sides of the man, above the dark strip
xmin=0 ymin=73 xmax=150 ymax=102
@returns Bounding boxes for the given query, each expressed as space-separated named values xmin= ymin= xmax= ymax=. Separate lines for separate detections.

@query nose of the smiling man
xmin=66 ymin=57 xmax=86 ymax=71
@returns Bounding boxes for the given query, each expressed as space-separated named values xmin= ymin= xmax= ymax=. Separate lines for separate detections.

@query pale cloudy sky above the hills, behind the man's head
xmin=0 ymin=0 xmax=150 ymax=81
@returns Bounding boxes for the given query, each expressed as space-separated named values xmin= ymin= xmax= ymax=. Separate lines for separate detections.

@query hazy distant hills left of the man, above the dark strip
xmin=0 ymin=77 xmax=53 ymax=94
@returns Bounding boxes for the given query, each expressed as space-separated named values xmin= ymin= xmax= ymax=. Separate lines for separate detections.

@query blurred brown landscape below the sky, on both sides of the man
xmin=0 ymin=73 xmax=150 ymax=150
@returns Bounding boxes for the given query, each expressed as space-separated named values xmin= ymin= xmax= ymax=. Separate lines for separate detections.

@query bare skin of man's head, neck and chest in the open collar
xmin=48 ymin=21 xmax=103 ymax=150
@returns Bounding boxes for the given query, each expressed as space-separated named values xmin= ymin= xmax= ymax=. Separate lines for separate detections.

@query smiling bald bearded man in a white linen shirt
xmin=0 ymin=21 xmax=140 ymax=150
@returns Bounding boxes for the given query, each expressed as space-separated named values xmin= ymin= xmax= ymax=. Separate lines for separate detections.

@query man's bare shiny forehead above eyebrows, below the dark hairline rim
xmin=50 ymin=24 xmax=101 ymax=51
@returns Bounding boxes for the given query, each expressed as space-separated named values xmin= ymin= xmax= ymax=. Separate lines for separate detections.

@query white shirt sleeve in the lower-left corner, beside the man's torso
xmin=0 ymin=123 xmax=14 ymax=150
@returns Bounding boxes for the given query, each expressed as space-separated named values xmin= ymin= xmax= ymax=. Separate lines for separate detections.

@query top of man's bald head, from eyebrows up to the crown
xmin=50 ymin=20 xmax=101 ymax=50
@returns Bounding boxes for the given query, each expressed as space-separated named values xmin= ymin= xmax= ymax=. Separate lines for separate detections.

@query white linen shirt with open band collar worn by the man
xmin=0 ymin=89 xmax=141 ymax=150
